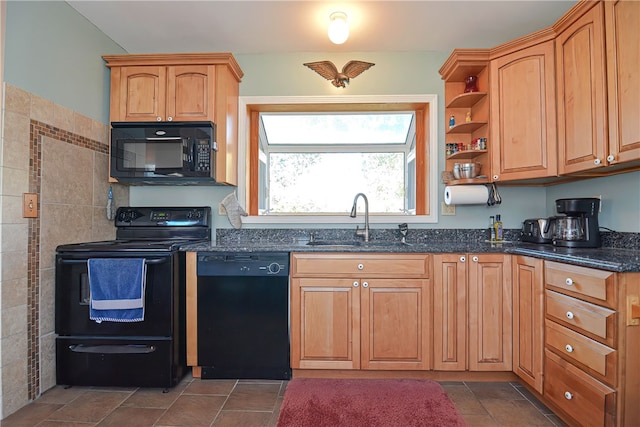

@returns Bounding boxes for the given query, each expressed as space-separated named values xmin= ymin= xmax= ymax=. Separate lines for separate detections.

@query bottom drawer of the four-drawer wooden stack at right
xmin=544 ymin=350 xmax=616 ymax=427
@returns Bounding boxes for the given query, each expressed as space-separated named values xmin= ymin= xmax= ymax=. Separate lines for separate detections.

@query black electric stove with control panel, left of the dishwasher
xmin=55 ymin=207 xmax=211 ymax=387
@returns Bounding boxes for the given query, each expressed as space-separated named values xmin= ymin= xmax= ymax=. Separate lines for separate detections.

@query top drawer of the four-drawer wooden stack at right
xmin=544 ymin=261 xmax=617 ymax=309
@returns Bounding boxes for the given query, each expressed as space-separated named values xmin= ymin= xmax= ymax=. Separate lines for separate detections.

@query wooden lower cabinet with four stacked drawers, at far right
xmin=543 ymin=261 xmax=640 ymax=427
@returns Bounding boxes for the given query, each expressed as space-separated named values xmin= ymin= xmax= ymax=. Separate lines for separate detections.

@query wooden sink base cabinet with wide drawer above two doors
xmin=291 ymin=253 xmax=431 ymax=370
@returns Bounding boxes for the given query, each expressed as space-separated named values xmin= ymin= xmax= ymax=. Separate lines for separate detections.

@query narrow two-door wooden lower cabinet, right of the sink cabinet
xmin=433 ymin=254 xmax=513 ymax=371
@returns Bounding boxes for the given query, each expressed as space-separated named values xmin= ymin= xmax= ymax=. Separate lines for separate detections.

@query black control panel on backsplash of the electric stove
xmin=115 ymin=206 xmax=211 ymax=227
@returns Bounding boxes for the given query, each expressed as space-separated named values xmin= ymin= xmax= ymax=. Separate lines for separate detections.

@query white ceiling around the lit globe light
xmin=68 ymin=0 xmax=576 ymax=54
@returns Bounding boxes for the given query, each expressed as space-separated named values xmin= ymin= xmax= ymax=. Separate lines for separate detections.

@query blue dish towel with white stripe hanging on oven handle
xmin=87 ymin=258 xmax=147 ymax=323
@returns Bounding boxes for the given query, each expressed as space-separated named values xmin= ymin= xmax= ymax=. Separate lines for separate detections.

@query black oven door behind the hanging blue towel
xmin=55 ymin=251 xmax=185 ymax=337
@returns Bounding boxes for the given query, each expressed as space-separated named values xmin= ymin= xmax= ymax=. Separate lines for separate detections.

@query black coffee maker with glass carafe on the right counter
xmin=553 ymin=198 xmax=600 ymax=248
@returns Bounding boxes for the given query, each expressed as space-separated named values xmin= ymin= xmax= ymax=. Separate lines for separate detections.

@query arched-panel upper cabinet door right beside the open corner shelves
xmin=491 ymin=40 xmax=558 ymax=181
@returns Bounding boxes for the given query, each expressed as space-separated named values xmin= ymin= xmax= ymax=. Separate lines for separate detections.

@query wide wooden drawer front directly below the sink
xmin=291 ymin=253 xmax=429 ymax=279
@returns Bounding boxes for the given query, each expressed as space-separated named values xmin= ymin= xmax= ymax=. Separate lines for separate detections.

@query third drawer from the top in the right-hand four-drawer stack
xmin=545 ymin=320 xmax=618 ymax=385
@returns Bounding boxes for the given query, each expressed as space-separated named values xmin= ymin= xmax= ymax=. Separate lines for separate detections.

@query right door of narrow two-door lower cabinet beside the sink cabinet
xmin=467 ymin=254 xmax=513 ymax=371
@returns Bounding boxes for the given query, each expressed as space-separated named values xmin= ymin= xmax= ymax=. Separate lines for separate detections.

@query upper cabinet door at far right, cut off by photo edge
xmin=604 ymin=1 xmax=640 ymax=163
